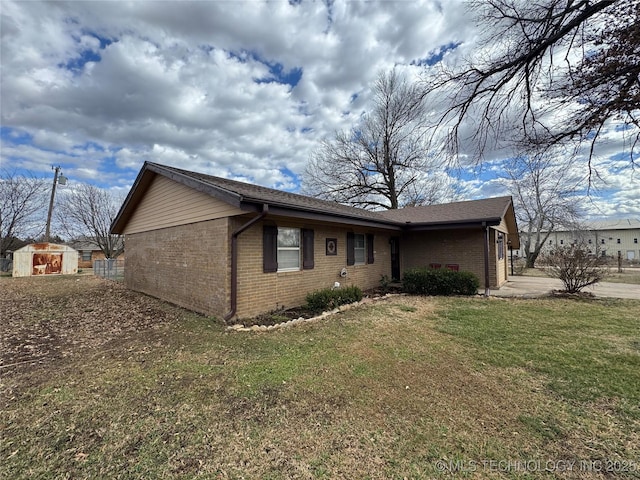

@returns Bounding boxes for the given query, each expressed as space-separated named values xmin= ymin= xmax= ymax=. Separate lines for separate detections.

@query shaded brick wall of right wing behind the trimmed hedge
xmin=400 ymin=229 xmax=506 ymax=288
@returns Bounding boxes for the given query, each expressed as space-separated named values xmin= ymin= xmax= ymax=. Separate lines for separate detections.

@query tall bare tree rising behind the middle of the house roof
xmin=303 ymin=70 xmax=449 ymax=209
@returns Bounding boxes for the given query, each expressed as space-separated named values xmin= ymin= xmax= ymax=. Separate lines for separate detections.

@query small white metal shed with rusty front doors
xmin=13 ymin=243 xmax=78 ymax=277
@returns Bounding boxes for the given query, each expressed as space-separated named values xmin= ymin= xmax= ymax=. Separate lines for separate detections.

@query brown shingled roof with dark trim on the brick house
xmin=111 ymin=162 xmax=517 ymax=242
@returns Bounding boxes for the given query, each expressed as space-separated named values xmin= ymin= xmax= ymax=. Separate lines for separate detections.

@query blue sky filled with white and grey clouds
xmin=0 ymin=0 xmax=640 ymax=218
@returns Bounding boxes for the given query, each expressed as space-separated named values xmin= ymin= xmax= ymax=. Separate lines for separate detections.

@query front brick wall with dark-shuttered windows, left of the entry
xmin=234 ymin=219 xmax=391 ymax=318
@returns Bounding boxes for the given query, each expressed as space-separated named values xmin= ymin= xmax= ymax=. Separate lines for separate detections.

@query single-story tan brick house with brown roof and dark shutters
xmin=111 ymin=162 xmax=519 ymax=320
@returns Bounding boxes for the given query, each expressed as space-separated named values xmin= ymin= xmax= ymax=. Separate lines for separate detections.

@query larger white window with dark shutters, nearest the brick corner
xmin=262 ymin=225 xmax=314 ymax=273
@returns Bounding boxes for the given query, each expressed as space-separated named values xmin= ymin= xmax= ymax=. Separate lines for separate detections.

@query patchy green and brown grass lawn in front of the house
xmin=0 ymin=280 xmax=640 ymax=479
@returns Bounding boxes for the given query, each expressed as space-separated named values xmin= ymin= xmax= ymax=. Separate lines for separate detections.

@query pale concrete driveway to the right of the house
xmin=490 ymin=276 xmax=640 ymax=300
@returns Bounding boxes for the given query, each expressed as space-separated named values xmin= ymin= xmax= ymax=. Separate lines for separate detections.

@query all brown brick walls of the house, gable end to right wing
xmin=125 ymin=216 xmax=507 ymax=318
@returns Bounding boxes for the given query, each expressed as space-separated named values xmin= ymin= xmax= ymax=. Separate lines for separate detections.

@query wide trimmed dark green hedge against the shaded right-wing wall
xmin=402 ymin=268 xmax=480 ymax=295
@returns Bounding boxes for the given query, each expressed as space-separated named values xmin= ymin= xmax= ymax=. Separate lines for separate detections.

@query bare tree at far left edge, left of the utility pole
xmin=0 ymin=170 xmax=47 ymax=257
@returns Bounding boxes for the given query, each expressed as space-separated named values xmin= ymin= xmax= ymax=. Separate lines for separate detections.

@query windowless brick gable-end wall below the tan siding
xmin=125 ymin=218 xmax=230 ymax=317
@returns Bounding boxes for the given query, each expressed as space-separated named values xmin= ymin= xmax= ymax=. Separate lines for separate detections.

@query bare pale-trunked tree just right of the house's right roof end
xmin=503 ymin=156 xmax=581 ymax=268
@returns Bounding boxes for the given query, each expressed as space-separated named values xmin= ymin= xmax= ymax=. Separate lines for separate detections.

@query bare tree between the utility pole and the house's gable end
xmin=56 ymin=184 xmax=124 ymax=258
